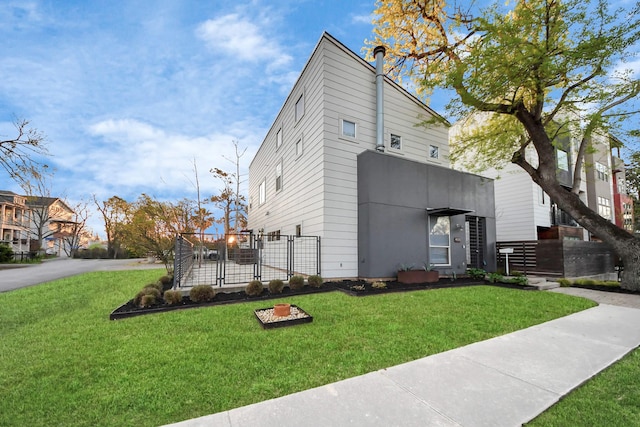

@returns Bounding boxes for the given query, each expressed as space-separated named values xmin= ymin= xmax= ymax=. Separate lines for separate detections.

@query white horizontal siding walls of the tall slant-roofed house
xmin=248 ymin=35 xmax=448 ymax=278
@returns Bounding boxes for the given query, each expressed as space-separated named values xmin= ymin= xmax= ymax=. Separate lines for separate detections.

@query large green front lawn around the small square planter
xmin=0 ymin=270 xmax=594 ymax=427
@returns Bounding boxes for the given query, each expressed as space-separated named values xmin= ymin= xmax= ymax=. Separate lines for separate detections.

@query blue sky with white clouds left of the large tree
xmin=0 ymin=0 xmax=388 ymax=237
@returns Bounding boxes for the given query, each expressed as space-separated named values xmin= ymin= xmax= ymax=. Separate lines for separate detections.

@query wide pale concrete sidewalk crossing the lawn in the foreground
xmin=162 ymin=302 xmax=640 ymax=427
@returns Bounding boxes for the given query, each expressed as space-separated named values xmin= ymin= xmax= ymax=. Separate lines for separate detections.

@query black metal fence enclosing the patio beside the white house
xmin=175 ymin=233 xmax=320 ymax=286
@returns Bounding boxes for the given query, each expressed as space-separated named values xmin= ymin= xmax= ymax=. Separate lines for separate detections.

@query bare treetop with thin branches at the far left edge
xmin=0 ymin=119 xmax=49 ymax=188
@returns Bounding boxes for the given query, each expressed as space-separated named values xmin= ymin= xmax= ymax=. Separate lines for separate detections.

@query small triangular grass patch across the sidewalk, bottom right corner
xmin=527 ymin=349 xmax=640 ymax=427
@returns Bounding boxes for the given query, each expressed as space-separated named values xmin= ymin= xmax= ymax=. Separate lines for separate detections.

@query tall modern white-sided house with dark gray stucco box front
xmin=248 ymin=33 xmax=495 ymax=278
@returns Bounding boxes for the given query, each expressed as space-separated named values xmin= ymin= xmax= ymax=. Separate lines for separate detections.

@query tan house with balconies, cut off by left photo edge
xmin=0 ymin=190 xmax=29 ymax=253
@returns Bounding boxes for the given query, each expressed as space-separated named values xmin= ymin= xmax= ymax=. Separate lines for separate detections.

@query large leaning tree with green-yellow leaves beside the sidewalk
xmin=369 ymin=0 xmax=640 ymax=290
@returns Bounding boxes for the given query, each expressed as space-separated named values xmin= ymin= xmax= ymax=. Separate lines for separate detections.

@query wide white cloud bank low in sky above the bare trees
xmin=79 ymin=119 xmax=257 ymax=198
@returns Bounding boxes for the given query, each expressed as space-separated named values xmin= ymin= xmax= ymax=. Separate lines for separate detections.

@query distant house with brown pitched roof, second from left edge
xmin=24 ymin=196 xmax=76 ymax=256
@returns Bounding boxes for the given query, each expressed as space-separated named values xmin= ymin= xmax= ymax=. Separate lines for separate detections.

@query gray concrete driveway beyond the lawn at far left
xmin=0 ymin=258 xmax=164 ymax=292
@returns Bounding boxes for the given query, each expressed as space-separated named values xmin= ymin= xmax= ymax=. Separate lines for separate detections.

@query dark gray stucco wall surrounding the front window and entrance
xmin=358 ymin=151 xmax=496 ymax=278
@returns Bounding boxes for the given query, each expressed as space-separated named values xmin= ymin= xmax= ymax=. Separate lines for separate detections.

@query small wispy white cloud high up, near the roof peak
xmin=196 ymin=13 xmax=292 ymax=68
